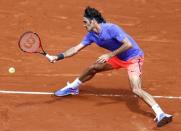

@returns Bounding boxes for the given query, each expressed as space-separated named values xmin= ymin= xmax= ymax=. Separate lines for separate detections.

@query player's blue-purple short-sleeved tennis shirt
xmin=81 ymin=23 xmax=144 ymax=61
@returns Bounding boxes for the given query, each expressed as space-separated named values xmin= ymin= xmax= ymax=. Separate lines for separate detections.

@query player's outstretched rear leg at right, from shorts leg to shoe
xmin=128 ymin=58 xmax=172 ymax=127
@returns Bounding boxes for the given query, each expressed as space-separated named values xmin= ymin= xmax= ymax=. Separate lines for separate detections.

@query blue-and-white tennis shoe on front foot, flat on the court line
xmin=54 ymin=83 xmax=79 ymax=96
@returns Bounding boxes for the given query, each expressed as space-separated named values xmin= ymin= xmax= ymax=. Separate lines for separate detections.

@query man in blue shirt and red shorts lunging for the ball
xmin=49 ymin=7 xmax=173 ymax=127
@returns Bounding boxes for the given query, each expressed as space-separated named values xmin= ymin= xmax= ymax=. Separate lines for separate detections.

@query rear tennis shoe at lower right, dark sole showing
xmin=155 ymin=113 xmax=173 ymax=127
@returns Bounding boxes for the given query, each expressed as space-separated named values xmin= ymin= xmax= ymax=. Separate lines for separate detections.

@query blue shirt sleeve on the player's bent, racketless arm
xmin=110 ymin=25 xmax=126 ymax=42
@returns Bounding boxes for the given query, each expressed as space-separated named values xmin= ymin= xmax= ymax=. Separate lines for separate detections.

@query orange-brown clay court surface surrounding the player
xmin=0 ymin=0 xmax=181 ymax=131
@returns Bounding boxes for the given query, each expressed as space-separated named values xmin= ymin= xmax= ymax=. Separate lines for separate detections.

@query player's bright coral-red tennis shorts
xmin=107 ymin=56 xmax=144 ymax=76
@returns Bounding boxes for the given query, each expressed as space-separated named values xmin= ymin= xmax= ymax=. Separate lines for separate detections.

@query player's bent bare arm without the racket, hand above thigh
xmin=97 ymin=37 xmax=132 ymax=63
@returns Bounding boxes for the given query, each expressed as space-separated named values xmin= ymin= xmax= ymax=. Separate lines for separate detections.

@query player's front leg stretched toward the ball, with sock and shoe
xmin=55 ymin=63 xmax=113 ymax=96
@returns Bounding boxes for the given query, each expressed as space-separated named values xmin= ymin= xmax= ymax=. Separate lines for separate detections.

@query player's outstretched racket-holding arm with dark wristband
xmin=46 ymin=43 xmax=86 ymax=63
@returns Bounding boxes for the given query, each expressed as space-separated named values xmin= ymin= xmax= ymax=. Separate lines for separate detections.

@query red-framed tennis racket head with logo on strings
xmin=18 ymin=31 xmax=46 ymax=55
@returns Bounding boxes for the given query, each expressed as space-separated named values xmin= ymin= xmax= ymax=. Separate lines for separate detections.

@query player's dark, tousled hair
xmin=84 ymin=6 xmax=106 ymax=23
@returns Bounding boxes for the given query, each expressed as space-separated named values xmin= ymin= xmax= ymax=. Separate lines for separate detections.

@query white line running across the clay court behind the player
xmin=0 ymin=90 xmax=181 ymax=99
